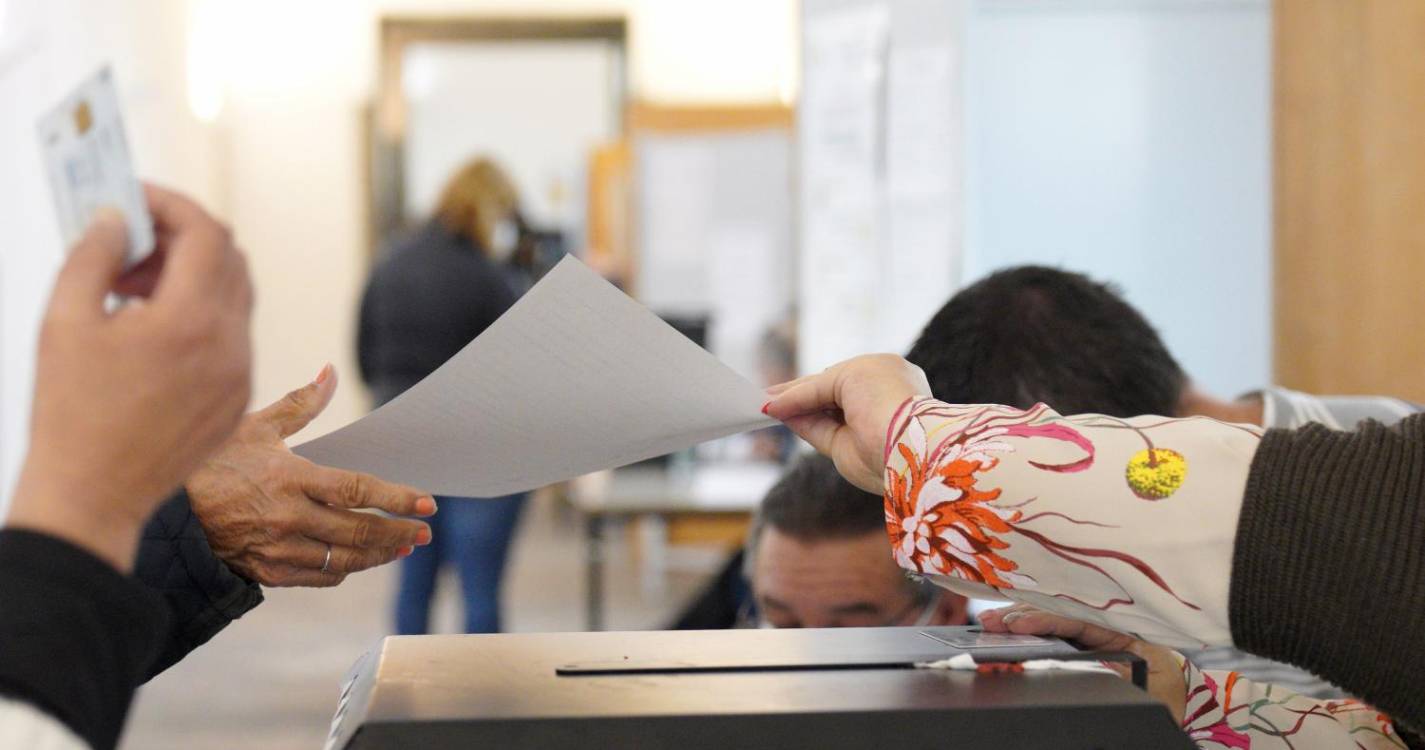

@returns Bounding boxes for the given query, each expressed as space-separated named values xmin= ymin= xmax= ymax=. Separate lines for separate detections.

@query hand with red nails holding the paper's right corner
xmin=762 ymin=354 xmax=931 ymax=495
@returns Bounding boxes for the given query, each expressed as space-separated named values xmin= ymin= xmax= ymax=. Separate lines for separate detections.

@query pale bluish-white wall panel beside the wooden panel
xmin=965 ymin=0 xmax=1271 ymax=395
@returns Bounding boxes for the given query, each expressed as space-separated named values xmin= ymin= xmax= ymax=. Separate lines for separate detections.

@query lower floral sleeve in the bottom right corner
xmin=1174 ymin=654 xmax=1406 ymax=750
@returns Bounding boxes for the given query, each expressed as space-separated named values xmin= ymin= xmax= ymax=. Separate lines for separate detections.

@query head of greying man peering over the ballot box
xmin=747 ymin=455 xmax=968 ymax=627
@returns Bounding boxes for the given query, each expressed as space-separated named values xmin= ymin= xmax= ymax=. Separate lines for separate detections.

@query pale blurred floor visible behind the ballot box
xmin=123 ymin=498 xmax=715 ymax=750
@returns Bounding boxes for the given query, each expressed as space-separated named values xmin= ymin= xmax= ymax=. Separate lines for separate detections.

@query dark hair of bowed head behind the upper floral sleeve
xmin=906 ymin=265 xmax=1187 ymax=416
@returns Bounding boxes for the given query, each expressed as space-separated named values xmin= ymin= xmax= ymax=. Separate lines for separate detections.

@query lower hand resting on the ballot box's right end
xmin=979 ymin=605 xmax=1187 ymax=723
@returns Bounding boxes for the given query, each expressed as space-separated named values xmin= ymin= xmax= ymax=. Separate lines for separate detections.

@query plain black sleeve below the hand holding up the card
xmin=0 ymin=529 xmax=168 ymax=750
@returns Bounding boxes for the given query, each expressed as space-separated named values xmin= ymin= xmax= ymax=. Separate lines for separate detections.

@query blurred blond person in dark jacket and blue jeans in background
xmin=358 ymin=157 xmax=529 ymax=635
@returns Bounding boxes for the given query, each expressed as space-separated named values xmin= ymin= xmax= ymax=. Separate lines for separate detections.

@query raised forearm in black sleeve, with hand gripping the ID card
xmin=0 ymin=188 xmax=252 ymax=750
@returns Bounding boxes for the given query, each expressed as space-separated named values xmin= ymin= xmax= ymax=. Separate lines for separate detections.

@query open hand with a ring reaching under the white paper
xmin=185 ymin=365 xmax=436 ymax=586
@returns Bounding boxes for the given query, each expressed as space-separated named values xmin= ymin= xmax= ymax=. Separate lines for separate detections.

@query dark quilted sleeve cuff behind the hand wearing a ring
xmin=134 ymin=492 xmax=262 ymax=680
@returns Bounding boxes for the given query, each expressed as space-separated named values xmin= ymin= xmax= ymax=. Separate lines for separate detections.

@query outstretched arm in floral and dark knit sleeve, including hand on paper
xmin=767 ymin=355 xmax=1425 ymax=731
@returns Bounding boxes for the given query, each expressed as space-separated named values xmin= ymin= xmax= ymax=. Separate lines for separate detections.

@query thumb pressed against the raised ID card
xmin=50 ymin=208 xmax=128 ymax=315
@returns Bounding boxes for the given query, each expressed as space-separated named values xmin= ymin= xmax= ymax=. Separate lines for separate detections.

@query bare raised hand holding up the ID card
xmin=10 ymin=187 xmax=252 ymax=570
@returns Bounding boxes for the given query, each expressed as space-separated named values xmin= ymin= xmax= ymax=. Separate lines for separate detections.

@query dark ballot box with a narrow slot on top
xmin=328 ymin=627 xmax=1193 ymax=750
